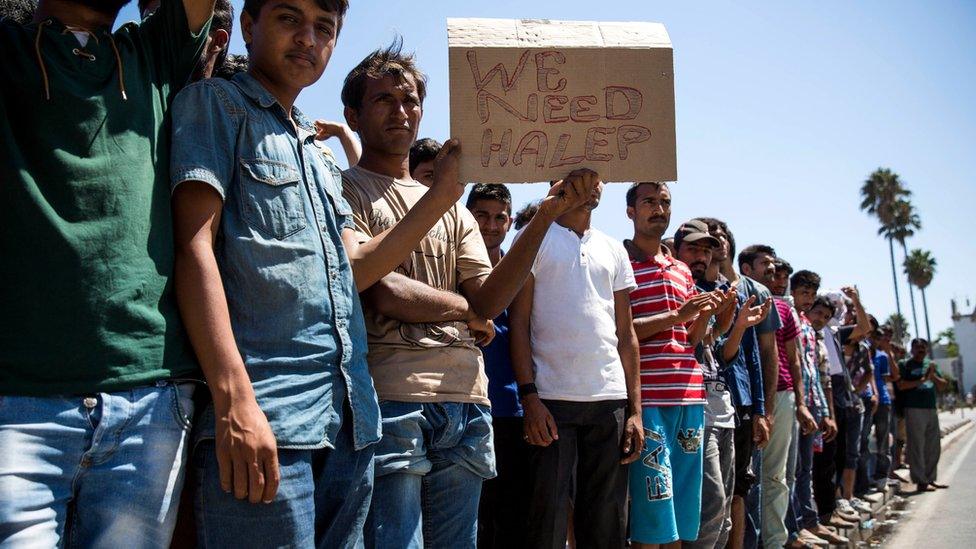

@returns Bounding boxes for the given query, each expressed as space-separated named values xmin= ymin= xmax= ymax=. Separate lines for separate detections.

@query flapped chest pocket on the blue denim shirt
xmin=240 ymin=158 xmax=308 ymax=240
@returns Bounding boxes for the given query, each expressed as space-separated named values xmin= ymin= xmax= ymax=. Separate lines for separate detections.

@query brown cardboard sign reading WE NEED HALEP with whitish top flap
xmin=447 ymin=19 xmax=677 ymax=183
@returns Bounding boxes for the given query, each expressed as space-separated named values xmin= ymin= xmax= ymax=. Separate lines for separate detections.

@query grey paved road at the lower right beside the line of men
xmin=883 ymin=412 xmax=976 ymax=549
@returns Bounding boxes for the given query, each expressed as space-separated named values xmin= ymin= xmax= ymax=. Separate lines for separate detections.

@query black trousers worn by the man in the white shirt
xmin=526 ymin=400 xmax=628 ymax=549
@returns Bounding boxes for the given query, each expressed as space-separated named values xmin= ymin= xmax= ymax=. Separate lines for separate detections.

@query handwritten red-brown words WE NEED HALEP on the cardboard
xmin=466 ymin=50 xmax=651 ymax=168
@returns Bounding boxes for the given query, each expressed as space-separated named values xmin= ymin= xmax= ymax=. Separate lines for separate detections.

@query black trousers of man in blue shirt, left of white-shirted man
xmin=478 ymin=417 xmax=532 ymax=549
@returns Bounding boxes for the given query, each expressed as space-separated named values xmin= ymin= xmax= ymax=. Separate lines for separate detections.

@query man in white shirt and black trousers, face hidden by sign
xmin=509 ymin=181 xmax=644 ymax=548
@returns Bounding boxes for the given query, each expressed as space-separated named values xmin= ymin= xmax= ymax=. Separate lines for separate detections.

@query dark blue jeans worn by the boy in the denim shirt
xmin=193 ymin=408 xmax=375 ymax=548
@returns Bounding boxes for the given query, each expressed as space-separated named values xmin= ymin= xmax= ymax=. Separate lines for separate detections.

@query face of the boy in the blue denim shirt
xmin=241 ymin=0 xmax=339 ymax=90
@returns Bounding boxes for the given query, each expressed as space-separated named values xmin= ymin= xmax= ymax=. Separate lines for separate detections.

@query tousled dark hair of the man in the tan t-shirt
xmin=342 ymin=37 xmax=427 ymax=110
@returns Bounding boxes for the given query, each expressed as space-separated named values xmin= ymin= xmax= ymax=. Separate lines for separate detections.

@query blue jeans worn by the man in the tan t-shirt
xmin=365 ymin=401 xmax=495 ymax=548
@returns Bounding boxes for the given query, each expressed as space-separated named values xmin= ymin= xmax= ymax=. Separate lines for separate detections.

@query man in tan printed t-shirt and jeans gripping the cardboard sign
xmin=342 ymin=40 xmax=598 ymax=547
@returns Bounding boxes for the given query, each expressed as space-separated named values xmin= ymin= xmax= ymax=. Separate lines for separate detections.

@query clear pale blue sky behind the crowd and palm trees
xmin=122 ymin=0 xmax=976 ymax=336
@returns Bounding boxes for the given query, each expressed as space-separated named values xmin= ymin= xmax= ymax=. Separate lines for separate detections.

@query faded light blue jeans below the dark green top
xmin=0 ymin=382 xmax=194 ymax=547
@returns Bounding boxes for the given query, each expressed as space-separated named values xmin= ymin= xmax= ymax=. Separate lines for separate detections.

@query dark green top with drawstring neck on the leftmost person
xmin=0 ymin=0 xmax=209 ymax=395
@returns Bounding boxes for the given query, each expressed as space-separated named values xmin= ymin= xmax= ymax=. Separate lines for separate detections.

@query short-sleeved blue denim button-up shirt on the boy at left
xmin=170 ymin=74 xmax=380 ymax=449
